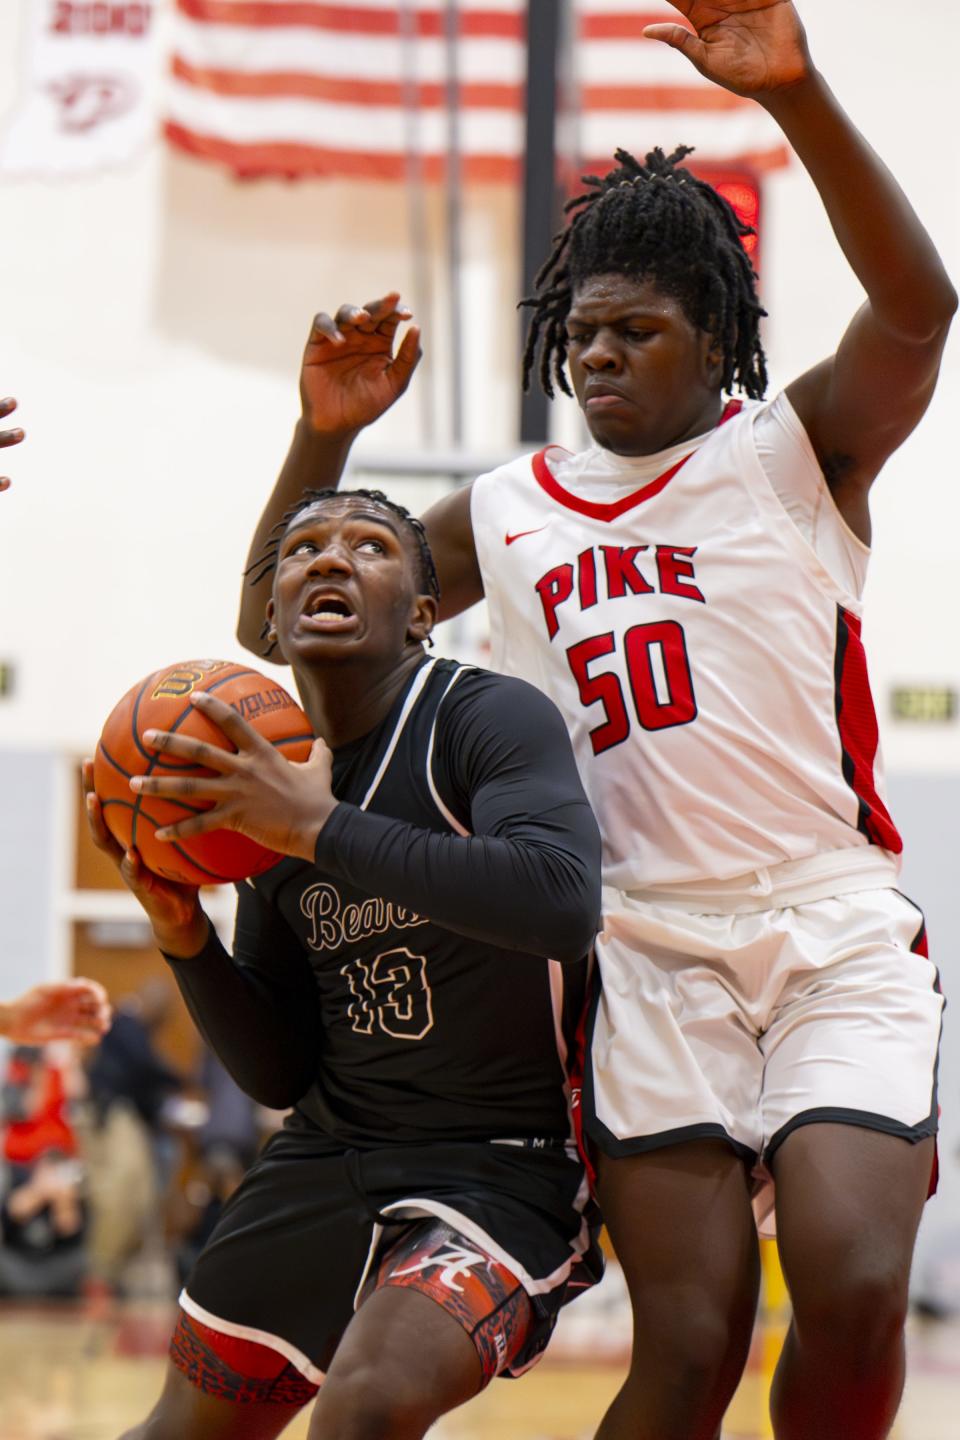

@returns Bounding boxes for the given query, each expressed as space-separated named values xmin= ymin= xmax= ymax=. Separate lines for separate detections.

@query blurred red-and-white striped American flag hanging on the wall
xmin=166 ymin=0 xmax=787 ymax=181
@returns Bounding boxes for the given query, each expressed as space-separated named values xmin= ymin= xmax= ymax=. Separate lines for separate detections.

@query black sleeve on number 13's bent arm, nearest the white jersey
xmin=315 ymin=671 xmax=600 ymax=960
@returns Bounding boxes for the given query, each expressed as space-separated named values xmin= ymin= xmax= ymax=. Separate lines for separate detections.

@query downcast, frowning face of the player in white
xmin=567 ymin=275 xmax=721 ymax=455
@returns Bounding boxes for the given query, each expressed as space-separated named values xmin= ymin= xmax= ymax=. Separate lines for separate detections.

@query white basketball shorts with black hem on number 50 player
xmin=583 ymin=888 xmax=943 ymax=1162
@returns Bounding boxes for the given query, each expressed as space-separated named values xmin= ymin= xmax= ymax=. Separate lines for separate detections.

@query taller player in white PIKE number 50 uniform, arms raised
xmin=239 ymin=0 xmax=957 ymax=1440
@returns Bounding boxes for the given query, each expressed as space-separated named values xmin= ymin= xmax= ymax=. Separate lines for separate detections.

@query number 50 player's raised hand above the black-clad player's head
xmin=299 ymin=292 xmax=420 ymax=435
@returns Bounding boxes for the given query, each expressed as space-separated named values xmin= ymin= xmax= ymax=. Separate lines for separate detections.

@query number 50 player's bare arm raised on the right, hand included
xmin=645 ymin=0 xmax=957 ymax=540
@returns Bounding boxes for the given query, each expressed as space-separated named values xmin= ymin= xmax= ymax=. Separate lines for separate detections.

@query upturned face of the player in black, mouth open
xmin=268 ymin=495 xmax=436 ymax=668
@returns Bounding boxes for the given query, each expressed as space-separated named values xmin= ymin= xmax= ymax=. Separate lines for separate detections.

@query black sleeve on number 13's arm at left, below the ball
xmin=166 ymin=886 xmax=321 ymax=1110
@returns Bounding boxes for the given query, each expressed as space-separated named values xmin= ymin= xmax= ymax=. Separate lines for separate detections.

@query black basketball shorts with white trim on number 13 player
xmin=171 ymin=1130 xmax=602 ymax=1404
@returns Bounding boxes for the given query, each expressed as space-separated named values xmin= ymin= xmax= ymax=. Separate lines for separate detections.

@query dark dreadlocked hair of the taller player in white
xmin=520 ymin=145 xmax=767 ymax=399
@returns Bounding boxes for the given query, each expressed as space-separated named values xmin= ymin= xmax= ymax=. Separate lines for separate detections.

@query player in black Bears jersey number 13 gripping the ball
xmin=85 ymin=492 xmax=600 ymax=1440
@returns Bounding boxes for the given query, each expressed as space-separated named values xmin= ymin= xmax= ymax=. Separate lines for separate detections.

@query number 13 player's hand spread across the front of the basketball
xmin=130 ymin=690 xmax=337 ymax=860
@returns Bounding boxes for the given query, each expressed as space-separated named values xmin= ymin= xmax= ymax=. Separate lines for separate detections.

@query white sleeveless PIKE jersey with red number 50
xmin=472 ymin=402 xmax=901 ymax=890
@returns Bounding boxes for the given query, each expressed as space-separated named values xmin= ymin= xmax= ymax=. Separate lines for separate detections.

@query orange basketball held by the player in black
xmin=94 ymin=660 xmax=314 ymax=886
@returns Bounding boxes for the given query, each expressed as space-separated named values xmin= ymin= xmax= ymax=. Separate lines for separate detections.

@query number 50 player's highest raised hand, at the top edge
xmin=643 ymin=0 xmax=812 ymax=101
